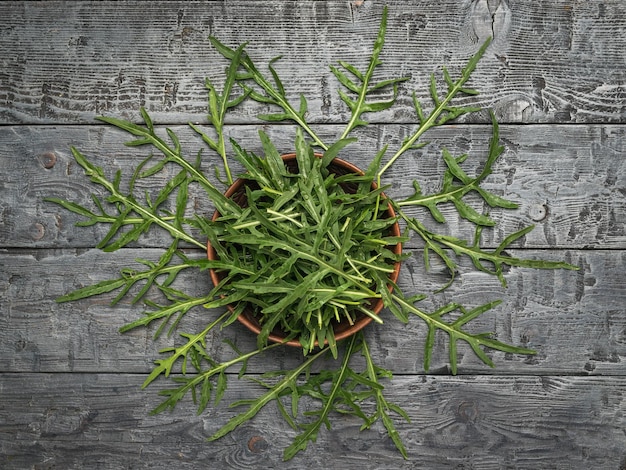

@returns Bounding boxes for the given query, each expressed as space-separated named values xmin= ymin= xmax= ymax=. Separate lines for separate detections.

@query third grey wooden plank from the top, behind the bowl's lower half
xmin=0 ymin=249 xmax=626 ymax=375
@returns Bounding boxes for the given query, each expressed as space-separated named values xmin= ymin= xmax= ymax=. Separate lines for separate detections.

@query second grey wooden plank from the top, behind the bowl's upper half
xmin=0 ymin=125 xmax=626 ymax=248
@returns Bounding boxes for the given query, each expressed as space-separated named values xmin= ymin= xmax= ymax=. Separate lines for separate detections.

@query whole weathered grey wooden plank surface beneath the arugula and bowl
xmin=0 ymin=0 xmax=626 ymax=470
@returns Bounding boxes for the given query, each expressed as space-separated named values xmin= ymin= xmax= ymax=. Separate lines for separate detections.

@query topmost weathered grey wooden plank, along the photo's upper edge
xmin=0 ymin=0 xmax=626 ymax=123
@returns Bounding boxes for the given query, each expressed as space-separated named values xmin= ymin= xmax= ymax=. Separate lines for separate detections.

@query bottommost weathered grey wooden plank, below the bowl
xmin=0 ymin=374 xmax=626 ymax=470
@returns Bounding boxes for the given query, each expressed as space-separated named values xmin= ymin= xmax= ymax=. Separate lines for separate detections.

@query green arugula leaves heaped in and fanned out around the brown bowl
xmin=48 ymin=8 xmax=576 ymax=459
